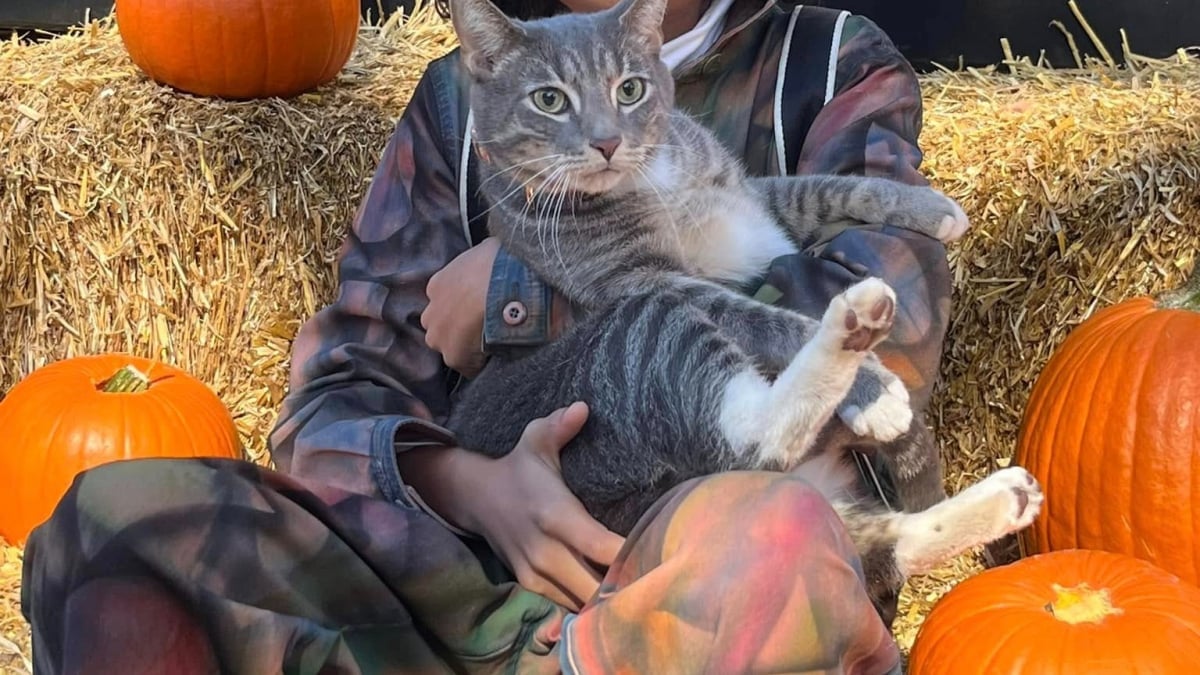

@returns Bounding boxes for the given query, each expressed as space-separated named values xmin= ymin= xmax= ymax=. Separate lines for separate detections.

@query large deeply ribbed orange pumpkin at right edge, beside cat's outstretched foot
xmin=1015 ymin=269 xmax=1200 ymax=583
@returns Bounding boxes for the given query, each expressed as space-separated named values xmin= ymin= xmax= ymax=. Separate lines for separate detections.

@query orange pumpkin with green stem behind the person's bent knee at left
xmin=0 ymin=354 xmax=241 ymax=544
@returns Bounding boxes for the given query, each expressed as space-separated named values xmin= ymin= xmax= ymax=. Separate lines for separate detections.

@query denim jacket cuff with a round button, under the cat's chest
xmin=484 ymin=246 xmax=553 ymax=353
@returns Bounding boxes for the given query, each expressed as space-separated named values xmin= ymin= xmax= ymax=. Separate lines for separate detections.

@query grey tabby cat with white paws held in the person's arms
xmin=448 ymin=0 xmax=1042 ymax=610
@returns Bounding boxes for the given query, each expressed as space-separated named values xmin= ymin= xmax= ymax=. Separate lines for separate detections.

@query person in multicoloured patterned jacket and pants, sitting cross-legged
xmin=22 ymin=0 xmax=949 ymax=675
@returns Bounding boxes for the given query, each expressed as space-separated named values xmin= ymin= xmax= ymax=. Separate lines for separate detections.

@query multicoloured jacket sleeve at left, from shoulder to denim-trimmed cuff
xmin=270 ymin=62 xmax=467 ymax=502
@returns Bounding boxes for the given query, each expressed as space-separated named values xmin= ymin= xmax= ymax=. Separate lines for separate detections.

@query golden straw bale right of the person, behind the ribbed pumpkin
xmin=896 ymin=55 xmax=1200 ymax=647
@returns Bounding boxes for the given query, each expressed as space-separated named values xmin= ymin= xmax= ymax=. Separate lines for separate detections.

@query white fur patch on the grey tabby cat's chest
xmin=676 ymin=183 xmax=797 ymax=285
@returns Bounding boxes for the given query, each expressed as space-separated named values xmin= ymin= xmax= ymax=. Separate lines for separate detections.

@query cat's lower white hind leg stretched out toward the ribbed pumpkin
xmin=895 ymin=467 xmax=1043 ymax=577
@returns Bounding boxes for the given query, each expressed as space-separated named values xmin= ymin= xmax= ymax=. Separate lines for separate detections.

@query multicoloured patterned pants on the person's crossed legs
xmin=22 ymin=460 xmax=900 ymax=675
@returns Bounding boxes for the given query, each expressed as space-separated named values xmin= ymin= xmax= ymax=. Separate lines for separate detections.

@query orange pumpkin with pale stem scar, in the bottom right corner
xmin=908 ymin=550 xmax=1200 ymax=675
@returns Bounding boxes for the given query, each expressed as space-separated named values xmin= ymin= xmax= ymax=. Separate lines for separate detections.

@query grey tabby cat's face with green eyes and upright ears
xmin=452 ymin=0 xmax=674 ymax=193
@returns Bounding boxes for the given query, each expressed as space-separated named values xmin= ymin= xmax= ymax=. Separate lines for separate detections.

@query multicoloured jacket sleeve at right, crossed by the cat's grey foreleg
xmin=768 ymin=16 xmax=950 ymax=408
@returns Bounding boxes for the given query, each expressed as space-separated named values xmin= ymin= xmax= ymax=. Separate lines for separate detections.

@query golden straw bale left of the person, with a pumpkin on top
xmin=0 ymin=5 xmax=452 ymax=460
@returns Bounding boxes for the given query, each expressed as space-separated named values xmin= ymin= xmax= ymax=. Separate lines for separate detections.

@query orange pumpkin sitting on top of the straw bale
xmin=116 ymin=0 xmax=359 ymax=98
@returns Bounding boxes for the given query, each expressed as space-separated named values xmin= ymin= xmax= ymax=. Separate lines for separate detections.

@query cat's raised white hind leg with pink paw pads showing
xmin=720 ymin=279 xmax=897 ymax=468
